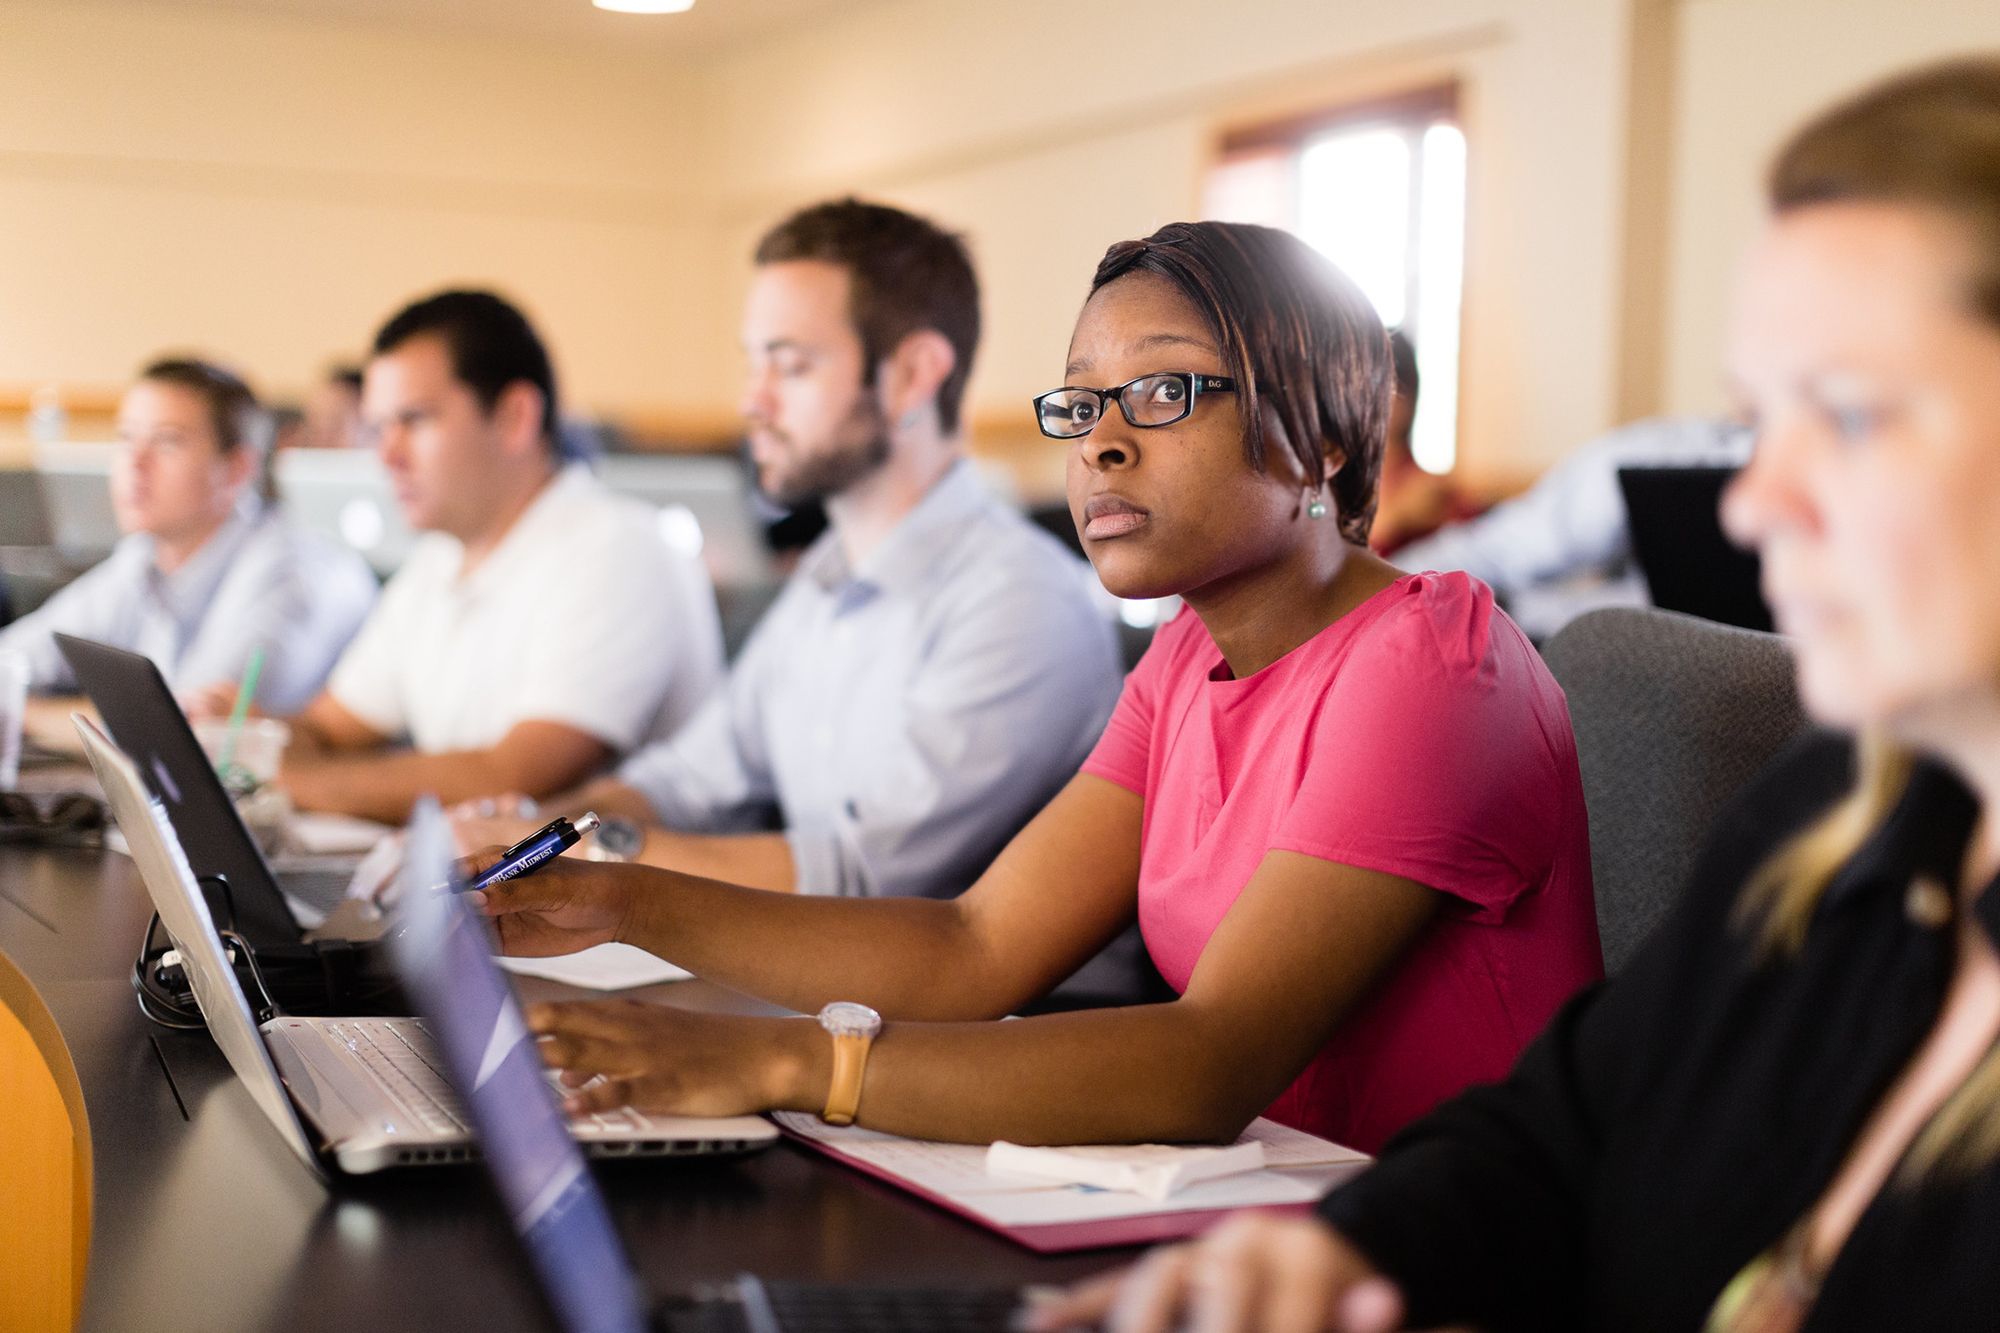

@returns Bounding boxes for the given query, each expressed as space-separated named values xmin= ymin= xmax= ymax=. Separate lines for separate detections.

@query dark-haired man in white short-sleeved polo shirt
xmin=270 ymin=292 xmax=722 ymax=823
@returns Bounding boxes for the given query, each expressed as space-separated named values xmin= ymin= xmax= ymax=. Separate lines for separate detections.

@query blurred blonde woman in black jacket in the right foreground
xmin=1036 ymin=58 xmax=2000 ymax=1333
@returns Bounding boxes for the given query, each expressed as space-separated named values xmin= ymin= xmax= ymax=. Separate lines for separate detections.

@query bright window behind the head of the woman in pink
xmin=1204 ymin=88 xmax=1466 ymax=472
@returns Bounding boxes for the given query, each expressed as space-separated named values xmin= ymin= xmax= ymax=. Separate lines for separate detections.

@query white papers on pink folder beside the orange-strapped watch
xmin=774 ymin=1111 xmax=1368 ymax=1227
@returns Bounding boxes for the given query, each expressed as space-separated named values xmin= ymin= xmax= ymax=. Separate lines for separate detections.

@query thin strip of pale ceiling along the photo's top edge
xmin=113 ymin=0 xmax=880 ymax=58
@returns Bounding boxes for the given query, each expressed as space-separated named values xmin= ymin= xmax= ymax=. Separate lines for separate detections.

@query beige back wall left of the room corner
xmin=0 ymin=4 xmax=718 ymax=408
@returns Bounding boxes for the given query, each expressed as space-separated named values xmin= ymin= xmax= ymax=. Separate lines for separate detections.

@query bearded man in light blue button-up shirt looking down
xmin=462 ymin=200 xmax=1138 ymax=993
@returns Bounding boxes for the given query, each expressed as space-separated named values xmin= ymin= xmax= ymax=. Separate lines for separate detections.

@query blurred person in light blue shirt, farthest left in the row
xmin=0 ymin=358 xmax=376 ymax=728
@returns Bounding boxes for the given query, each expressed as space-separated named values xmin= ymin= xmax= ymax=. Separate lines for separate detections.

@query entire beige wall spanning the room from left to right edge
xmin=11 ymin=0 xmax=2000 ymax=482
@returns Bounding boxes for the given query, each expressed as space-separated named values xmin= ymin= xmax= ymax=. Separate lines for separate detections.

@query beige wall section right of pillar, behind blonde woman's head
xmin=1664 ymin=0 xmax=2000 ymax=410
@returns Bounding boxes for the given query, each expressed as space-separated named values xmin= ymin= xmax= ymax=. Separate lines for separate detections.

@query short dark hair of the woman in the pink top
xmin=1090 ymin=222 xmax=1392 ymax=544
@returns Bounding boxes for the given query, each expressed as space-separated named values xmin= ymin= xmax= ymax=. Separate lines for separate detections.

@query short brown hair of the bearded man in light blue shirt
xmin=756 ymin=198 xmax=980 ymax=432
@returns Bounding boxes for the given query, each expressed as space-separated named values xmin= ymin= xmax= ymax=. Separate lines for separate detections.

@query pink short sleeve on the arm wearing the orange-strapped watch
xmin=1272 ymin=574 xmax=1568 ymax=921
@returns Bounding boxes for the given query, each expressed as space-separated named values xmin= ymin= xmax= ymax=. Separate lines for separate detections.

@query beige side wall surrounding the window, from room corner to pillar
xmin=710 ymin=0 xmax=1630 ymax=488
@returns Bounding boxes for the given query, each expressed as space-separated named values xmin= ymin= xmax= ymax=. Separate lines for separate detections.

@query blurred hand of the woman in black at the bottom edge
xmin=1026 ymin=1213 xmax=1404 ymax=1333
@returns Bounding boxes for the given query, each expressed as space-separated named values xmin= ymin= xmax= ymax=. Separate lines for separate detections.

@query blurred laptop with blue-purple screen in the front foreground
xmin=392 ymin=803 xmax=1020 ymax=1333
